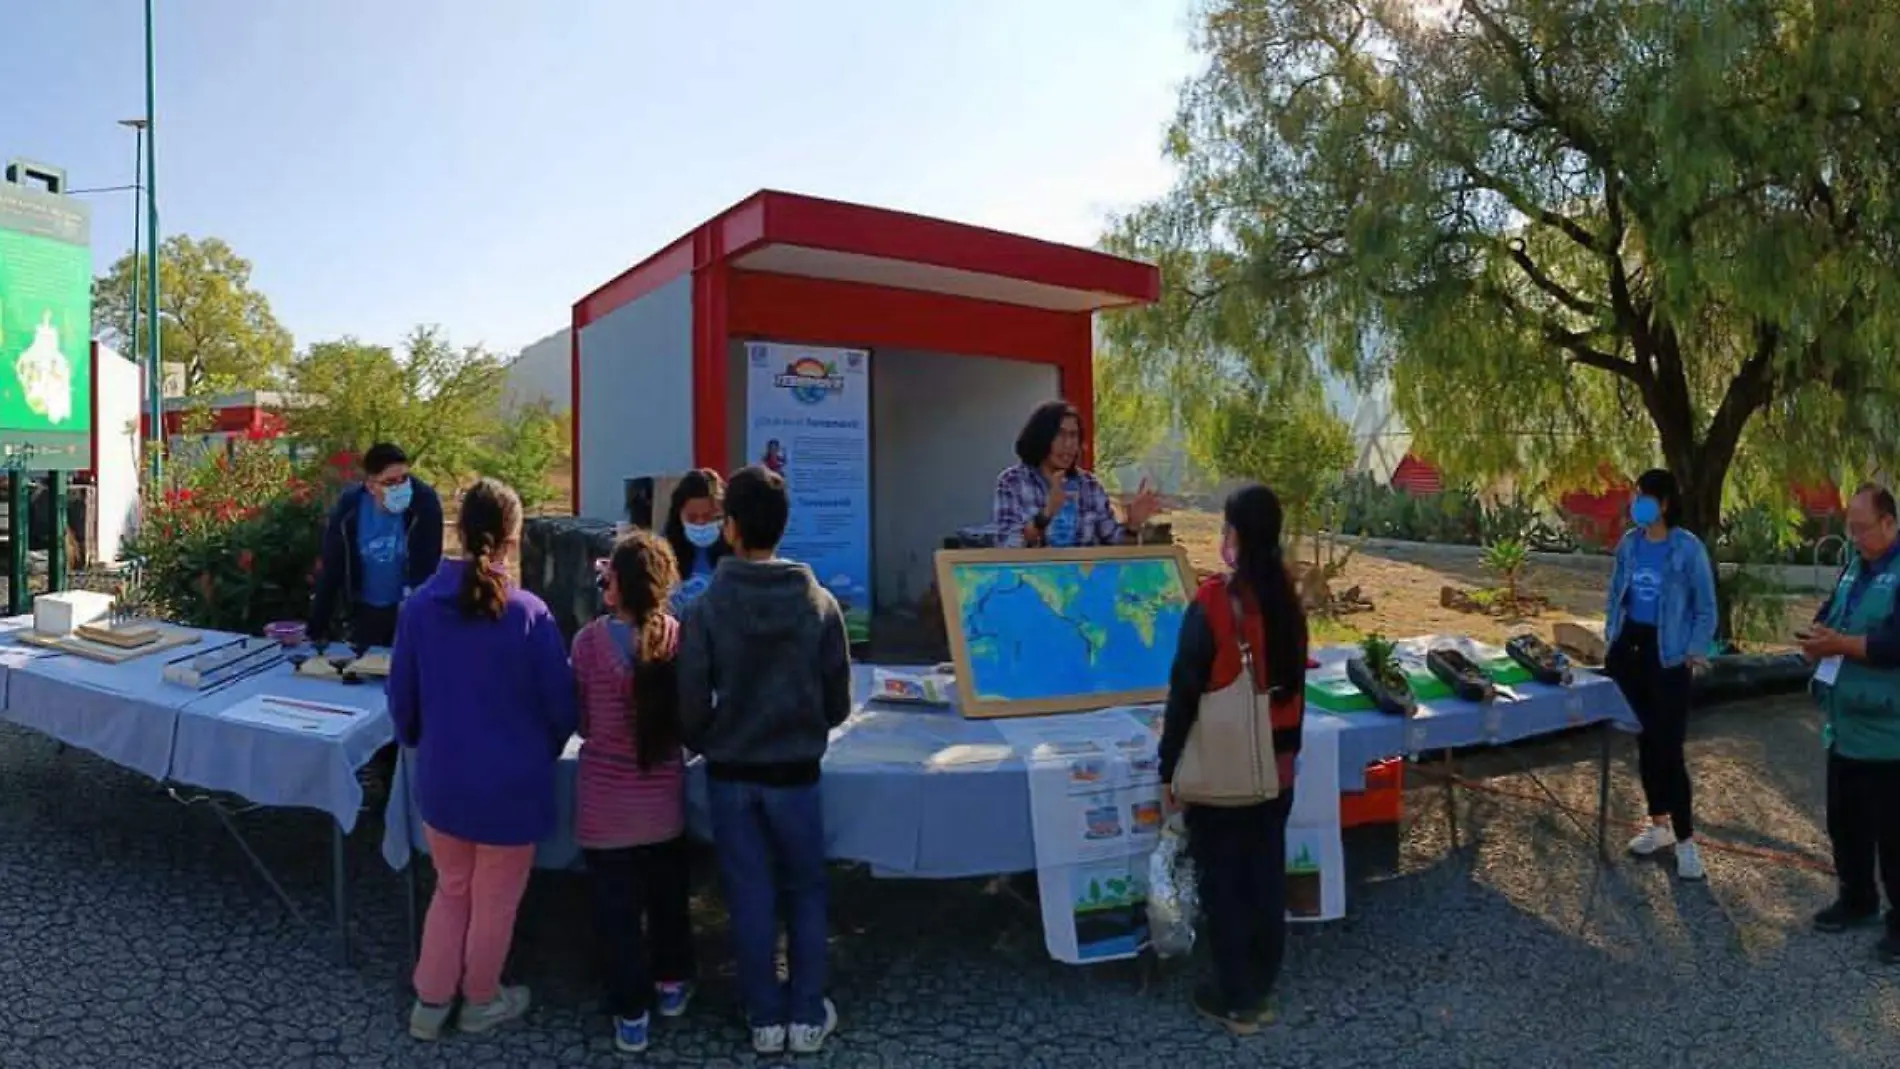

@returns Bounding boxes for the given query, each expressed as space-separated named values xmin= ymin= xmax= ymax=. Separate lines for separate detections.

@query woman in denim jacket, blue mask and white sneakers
xmin=1604 ymin=469 xmax=1716 ymax=879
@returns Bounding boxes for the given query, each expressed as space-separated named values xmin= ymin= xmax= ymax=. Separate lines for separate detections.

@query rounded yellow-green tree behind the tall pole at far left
xmin=93 ymin=234 xmax=291 ymax=397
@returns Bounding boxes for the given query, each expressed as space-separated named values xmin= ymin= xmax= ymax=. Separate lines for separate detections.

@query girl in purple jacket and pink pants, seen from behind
xmin=390 ymin=478 xmax=576 ymax=1041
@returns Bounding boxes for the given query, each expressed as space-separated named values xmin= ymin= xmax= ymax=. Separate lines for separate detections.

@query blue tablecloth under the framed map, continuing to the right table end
xmin=382 ymin=649 xmax=1636 ymax=879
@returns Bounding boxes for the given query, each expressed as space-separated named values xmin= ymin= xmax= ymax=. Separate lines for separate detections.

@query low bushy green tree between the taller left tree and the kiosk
xmin=287 ymin=327 xmax=507 ymax=484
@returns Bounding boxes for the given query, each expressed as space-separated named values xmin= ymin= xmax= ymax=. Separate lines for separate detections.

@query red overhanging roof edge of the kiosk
xmin=574 ymin=190 xmax=1161 ymax=328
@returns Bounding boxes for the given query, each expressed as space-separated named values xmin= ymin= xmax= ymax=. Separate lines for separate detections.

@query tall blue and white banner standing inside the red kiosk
xmin=745 ymin=342 xmax=870 ymax=642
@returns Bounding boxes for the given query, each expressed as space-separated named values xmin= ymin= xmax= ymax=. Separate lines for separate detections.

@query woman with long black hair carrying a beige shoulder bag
xmin=1161 ymin=484 xmax=1307 ymax=1035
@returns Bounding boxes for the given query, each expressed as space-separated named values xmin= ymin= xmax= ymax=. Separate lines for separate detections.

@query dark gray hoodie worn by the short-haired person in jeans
xmin=678 ymin=556 xmax=851 ymax=786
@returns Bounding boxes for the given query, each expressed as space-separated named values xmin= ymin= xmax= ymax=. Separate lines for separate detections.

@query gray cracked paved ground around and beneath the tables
xmin=0 ymin=701 xmax=1900 ymax=1069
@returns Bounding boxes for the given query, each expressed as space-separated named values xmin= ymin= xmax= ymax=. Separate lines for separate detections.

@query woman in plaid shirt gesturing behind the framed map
xmin=992 ymin=401 xmax=1161 ymax=547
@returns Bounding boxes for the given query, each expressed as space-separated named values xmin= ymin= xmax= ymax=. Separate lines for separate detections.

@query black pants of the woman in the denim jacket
xmin=1604 ymin=623 xmax=1695 ymax=839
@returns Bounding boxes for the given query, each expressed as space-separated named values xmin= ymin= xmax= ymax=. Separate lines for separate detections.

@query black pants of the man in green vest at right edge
xmin=1828 ymin=750 xmax=1900 ymax=930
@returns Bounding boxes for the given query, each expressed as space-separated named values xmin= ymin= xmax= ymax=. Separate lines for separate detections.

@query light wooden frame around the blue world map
xmin=937 ymin=545 xmax=1197 ymax=720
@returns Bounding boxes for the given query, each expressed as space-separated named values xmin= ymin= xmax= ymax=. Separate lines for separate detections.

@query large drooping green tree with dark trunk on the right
xmin=1110 ymin=0 xmax=1900 ymax=535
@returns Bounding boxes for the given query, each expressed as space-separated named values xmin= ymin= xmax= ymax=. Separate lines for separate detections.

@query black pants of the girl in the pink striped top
xmin=587 ymin=835 xmax=697 ymax=1020
